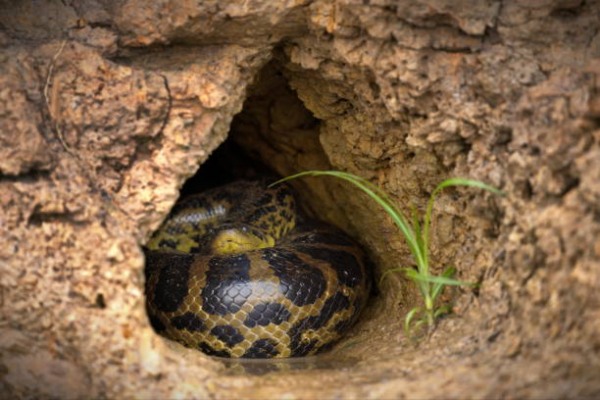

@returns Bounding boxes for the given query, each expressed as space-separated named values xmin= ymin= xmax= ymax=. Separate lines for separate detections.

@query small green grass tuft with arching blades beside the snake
xmin=272 ymin=171 xmax=503 ymax=335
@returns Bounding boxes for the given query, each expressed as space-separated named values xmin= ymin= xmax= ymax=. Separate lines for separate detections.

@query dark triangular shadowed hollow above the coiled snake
xmin=181 ymin=62 xmax=328 ymax=197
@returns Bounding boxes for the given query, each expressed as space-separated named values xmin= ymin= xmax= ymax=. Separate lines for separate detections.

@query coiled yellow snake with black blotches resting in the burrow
xmin=144 ymin=179 xmax=371 ymax=358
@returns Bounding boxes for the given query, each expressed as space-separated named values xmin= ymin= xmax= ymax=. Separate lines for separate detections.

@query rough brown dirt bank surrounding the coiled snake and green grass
xmin=0 ymin=0 xmax=600 ymax=399
